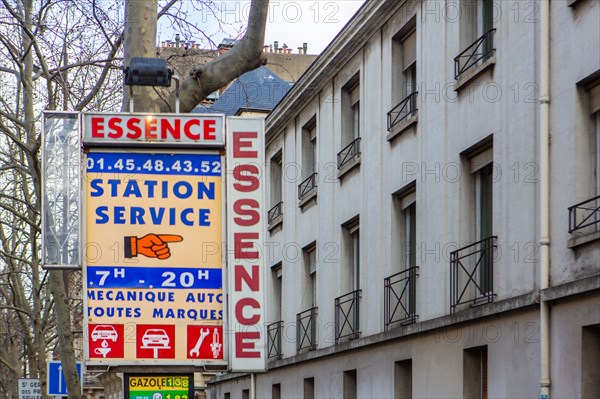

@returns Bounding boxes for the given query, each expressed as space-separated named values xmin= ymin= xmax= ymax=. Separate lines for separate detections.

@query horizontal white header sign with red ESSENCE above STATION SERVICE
xmin=83 ymin=113 xmax=225 ymax=147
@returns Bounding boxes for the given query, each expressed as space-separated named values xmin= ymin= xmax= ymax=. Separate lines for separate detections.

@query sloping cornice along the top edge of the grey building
xmin=265 ymin=0 xmax=406 ymax=143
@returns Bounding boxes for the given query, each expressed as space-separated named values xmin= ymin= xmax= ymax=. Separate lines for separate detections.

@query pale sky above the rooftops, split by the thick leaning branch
xmin=158 ymin=0 xmax=365 ymax=54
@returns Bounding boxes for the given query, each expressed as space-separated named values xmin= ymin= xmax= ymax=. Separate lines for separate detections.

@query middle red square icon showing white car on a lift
xmin=136 ymin=324 xmax=175 ymax=359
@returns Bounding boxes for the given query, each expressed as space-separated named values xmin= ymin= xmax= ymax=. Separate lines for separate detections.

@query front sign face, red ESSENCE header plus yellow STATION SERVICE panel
xmin=83 ymin=114 xmax=226 ymax=366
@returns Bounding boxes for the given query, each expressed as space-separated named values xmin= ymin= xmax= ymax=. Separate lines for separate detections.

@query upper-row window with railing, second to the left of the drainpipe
xmin=388 ymin=19 xmax=417 ymax=130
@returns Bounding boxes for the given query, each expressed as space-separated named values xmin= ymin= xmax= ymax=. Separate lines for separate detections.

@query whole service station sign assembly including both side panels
xmin=43 ymin=113 xmax=265 ymax=372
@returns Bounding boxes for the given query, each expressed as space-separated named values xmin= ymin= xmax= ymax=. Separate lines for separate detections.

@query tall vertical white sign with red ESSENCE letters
xmin=227 ymin=117 xmax=266 ymax=371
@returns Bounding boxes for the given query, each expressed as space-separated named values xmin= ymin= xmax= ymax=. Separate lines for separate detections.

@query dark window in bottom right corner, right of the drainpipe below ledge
xmin=581 ymin=324 xmax=600 ymax=398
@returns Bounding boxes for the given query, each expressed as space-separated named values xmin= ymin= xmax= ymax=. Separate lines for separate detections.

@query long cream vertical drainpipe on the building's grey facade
xmin=539 ymin=0 xmax=550 ymax=399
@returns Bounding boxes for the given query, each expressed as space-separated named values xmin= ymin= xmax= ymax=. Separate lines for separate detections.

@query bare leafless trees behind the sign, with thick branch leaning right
xmin=0 ymin=0 xmax=268 ymax=399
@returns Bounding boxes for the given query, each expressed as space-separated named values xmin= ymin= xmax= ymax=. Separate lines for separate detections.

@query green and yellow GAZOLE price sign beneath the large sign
xmin=125 ymin=374 xmax=194 ymax=399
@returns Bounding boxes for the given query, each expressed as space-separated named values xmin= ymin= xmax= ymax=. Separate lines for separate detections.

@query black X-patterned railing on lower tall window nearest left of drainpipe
xmin=450 ymin=236 xmax=497 ymax=313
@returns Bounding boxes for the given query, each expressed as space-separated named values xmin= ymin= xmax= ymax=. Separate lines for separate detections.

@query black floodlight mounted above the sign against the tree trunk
xmin=125 ymin=57 xmax=173 ymax=87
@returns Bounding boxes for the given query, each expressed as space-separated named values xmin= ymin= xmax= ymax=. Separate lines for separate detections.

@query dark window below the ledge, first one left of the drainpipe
xmin=463 ymin=346 xmax=488 ymax=399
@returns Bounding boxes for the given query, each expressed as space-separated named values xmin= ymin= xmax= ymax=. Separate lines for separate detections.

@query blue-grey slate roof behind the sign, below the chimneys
xmin=192 ymin=66 xmax=293 ymax=115
